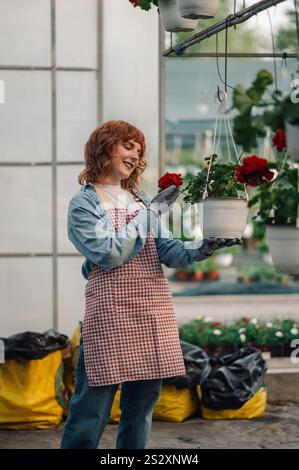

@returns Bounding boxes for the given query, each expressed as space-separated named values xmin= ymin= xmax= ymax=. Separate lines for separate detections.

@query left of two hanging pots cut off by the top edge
xmin=158 ymin=0 xmax=197 ymax=33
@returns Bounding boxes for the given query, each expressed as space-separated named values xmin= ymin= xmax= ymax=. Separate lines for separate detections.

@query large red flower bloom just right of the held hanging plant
xmin=235 ymin=155 xmax=274 ymax=186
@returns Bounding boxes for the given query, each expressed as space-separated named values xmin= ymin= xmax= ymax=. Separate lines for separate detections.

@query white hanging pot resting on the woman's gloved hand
xmin=197 ymin=197 xmax=249 ymax=238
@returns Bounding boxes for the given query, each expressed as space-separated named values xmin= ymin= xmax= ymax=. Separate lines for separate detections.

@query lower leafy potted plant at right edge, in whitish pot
xmin=249 ymin=151 xmax=299 ymax=274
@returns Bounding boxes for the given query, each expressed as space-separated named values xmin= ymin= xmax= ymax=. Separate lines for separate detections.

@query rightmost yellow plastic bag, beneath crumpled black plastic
xmin=196 ymin=385 xmax=267 ymax=419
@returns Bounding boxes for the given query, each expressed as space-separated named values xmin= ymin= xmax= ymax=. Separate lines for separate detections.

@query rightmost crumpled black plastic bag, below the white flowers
xmin=201 ymin=348 xmax=267 ymax=410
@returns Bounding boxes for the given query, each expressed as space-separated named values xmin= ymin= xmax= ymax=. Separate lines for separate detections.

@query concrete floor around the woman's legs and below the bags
xmin=0 ymin=403 xmax=299 ymax=449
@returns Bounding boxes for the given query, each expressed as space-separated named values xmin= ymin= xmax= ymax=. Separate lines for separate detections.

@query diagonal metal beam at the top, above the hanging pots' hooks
xmin=163 ymin=0 xmax=286 ymax=57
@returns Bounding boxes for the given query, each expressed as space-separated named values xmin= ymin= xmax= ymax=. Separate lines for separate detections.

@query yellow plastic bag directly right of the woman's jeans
xmin=153 ymin=384 xmax=198 ymax=423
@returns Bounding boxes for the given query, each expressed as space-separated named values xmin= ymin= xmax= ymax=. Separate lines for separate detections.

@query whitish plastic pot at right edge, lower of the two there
xmin=266 ymin=225 xmax=299 ymax=274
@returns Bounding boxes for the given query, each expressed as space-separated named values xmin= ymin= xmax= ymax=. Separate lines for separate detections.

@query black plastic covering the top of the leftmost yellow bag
xmin=1 ymin=329 xmax=69 ymax=360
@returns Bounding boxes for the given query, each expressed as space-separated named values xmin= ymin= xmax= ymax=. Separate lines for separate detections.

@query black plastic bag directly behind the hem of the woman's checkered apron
xmin=163 ymin=341 xmax=211 ymax=388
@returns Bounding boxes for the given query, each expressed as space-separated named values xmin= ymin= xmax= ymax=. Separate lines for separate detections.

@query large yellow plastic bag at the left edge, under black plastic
xmin=0 ymin=351 xmax=66 ymax=429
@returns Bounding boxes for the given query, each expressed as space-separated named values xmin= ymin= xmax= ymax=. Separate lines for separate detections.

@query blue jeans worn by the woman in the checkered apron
xmin=60 ymin=335 xmax=162 ymax=449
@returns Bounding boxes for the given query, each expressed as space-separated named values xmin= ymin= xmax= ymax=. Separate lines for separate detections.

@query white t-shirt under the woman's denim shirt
xmin=96 ymin=184 xmax=145 ymax=212
